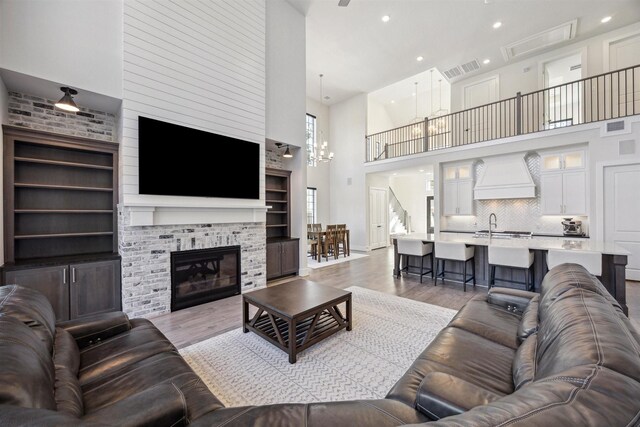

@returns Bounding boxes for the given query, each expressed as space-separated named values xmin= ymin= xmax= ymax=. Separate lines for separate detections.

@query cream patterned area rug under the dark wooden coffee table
xmin=180 ymin=286 xmax=456 ymax=406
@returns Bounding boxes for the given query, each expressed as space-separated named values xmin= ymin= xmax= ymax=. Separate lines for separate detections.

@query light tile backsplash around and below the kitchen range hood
xmin=440 ymin=153 xmax=589 ymax=235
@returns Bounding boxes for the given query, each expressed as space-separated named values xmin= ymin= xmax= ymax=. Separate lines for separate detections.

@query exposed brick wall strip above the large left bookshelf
xmin=8 ymin=92 xmax=117 ymax=142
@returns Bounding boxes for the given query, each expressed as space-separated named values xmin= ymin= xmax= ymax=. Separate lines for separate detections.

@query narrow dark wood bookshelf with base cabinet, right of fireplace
xmin=265 ymin=168 xmax=299 ymax=280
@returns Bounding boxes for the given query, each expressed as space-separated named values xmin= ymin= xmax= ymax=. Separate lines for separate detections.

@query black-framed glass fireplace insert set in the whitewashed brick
xmin=171 ymin=246 xmax=240 ymax=311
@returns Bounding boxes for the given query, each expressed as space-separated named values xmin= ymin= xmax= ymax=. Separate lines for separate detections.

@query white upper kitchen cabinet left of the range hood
xmin=442 ymin=164 xmax=473 ymax=216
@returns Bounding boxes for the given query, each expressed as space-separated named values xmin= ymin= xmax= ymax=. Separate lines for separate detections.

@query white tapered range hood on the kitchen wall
xmin=473 ymin=153 xmax=536 ymax=200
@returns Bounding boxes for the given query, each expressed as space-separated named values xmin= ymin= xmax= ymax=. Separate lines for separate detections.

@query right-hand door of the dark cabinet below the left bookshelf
xmin=69 ymin=261 xmax=121 ymax=319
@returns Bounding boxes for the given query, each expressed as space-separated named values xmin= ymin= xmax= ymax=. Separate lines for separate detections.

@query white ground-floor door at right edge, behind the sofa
xmin=604 ymin=163 xmax=640 ymax=280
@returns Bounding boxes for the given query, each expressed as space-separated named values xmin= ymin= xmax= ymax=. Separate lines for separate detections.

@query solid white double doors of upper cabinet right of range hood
xmin=540 ymin=171 xmax=587 ymax=215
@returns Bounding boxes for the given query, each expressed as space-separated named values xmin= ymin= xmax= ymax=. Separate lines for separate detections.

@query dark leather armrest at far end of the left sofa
xmin=56 ymin=311 xmax=131 ymax=348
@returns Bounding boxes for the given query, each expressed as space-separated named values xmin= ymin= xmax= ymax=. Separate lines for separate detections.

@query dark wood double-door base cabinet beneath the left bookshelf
xmin=2 ymin=257 xmax=121 ymax=321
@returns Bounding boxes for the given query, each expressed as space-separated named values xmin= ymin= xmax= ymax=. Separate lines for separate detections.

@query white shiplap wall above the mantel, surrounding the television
xmin=121 ymin=0 xmax=265 ymax=197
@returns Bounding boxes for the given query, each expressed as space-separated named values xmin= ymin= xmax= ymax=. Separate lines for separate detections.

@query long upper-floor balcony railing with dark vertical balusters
xmin=366 ymin=65 xmax=640 ymax=162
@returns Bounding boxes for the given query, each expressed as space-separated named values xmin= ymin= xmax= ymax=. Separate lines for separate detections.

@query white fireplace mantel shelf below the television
xmin=120 ymin=195 xmax=267 ymax=226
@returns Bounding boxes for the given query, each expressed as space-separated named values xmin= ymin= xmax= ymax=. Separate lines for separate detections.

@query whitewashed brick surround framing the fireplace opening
xmin=118 ymin=208 xmax=267 ymax=317
